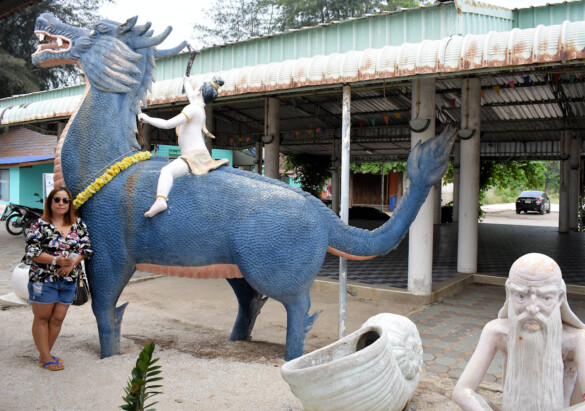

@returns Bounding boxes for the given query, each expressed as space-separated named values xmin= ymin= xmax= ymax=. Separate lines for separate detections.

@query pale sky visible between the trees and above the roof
xmin=100 ymin=0 xmax=563 ymax=49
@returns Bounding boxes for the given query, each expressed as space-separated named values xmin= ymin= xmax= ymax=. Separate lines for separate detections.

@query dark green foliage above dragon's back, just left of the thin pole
xmin=283 ymin=153 xmax=331 ymax=198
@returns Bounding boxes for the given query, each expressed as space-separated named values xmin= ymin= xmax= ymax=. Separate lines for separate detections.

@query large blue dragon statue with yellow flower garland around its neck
xmin=32 ymin=14 xmax=454 ymax=360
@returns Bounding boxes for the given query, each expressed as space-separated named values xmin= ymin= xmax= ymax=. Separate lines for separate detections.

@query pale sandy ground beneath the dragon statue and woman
xmin=0 ymin=277 xmax=474 ymax=411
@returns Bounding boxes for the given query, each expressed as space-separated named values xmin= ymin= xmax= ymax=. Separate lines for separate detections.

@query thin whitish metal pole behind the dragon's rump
xmin=339 ymin=86 xmax=351 ymax=338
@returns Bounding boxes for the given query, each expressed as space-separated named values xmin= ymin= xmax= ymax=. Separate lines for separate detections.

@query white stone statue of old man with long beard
xmin=453 ymin=253 xmax=585 ymax=411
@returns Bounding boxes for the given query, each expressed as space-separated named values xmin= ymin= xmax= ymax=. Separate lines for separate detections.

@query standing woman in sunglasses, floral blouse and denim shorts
xmin=22 ymin=187 xmax=93 ymax=371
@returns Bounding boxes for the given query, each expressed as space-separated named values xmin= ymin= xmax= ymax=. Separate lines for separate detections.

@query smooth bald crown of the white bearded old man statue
xmin=508 ymin=253 xmax=563 ymax=287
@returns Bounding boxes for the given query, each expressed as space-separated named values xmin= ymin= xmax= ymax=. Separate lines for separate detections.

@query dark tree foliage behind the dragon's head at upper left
xmin=0 ymin=0 xmax=112 ymax=98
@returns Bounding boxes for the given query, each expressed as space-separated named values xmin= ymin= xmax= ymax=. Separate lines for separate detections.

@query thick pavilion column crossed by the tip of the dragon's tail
xmin=408 ymin=78 xmax=435 ymax=295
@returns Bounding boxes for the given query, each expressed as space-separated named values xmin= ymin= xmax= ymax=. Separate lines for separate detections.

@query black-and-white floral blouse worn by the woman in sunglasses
xmin=22 ymin=218 xmax=93 ymax=282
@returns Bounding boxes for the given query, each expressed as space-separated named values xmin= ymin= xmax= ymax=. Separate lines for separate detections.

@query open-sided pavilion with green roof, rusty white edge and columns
xmin=0 ymin=0 xmax=585 ymax=296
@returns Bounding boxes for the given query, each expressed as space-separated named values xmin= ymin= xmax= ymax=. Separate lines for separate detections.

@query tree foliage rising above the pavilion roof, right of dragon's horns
xmin=194 ymin=0 xmax=418 ymax=46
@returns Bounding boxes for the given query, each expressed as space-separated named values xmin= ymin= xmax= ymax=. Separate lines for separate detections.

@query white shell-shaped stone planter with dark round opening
xmin=281 ymin=313 xmax=423 ymax=411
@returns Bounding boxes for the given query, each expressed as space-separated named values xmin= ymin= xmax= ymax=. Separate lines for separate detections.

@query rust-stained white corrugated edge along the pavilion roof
xmin=0 ymin=21 xmax=585 ymax=124
